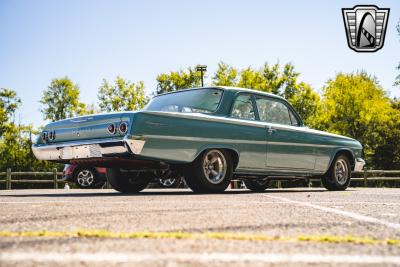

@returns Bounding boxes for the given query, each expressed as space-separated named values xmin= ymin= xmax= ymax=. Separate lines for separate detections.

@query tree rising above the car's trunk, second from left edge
xmin=40 ymin=77 xmax=85 ymax=121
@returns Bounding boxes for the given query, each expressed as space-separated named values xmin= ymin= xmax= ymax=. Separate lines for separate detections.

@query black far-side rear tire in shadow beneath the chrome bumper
xmin=107 ymin=169 xmax=154 ymax=193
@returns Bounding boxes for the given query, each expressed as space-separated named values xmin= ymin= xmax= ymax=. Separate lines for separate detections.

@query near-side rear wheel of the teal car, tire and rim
xmin=185 ymin=149 xmax=233 ymax=193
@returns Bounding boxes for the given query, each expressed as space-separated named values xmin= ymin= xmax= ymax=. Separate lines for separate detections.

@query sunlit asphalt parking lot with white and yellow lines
xmin=0 ymin=188 xmax=400 ymax=267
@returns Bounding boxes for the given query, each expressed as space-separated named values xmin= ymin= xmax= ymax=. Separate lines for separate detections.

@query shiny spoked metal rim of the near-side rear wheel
xmin=203 ymin=150 xmax=227 ymax=184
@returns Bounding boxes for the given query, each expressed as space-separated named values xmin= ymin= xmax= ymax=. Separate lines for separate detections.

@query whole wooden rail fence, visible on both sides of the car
xmin=0 ymin=169 xmax=400 ymax=190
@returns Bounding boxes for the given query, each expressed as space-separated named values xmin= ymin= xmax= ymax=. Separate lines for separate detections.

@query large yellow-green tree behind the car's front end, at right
xmin=315 ymin=72 xmax=396 ymax=166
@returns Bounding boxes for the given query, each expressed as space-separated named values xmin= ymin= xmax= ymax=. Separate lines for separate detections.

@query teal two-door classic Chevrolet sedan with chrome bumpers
xmin=33 ymin=87 xmax=365 ymax=192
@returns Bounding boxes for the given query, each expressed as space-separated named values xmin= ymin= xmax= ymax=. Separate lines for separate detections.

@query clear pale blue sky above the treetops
xmin=0 ymin=0 xmax=400 ymax=126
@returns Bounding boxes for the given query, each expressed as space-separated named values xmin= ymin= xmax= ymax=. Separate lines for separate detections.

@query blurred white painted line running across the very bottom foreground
xmin=0 ymin=252 xmax=400 ymax=265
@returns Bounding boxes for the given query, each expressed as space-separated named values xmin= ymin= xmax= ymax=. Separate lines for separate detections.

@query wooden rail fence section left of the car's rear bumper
xmin=0 ymin=169 xmax=64 ymax=190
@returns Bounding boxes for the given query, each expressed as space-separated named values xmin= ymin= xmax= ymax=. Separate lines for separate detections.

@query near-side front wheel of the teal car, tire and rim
xmin=321 ymin=155 xmax=351 ymax=191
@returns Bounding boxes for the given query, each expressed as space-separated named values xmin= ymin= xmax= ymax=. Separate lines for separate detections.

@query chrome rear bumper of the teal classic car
xmin=32 ymin=138 xmax=146 ymax=161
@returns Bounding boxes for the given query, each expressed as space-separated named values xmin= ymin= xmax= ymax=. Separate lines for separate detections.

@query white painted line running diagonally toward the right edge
xmin=265 ymin=195 xmax=400 ymax=230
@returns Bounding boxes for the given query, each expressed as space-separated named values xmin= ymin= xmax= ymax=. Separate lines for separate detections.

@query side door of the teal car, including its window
xmin=255 ymin=96 xmax=315 ymax=171
